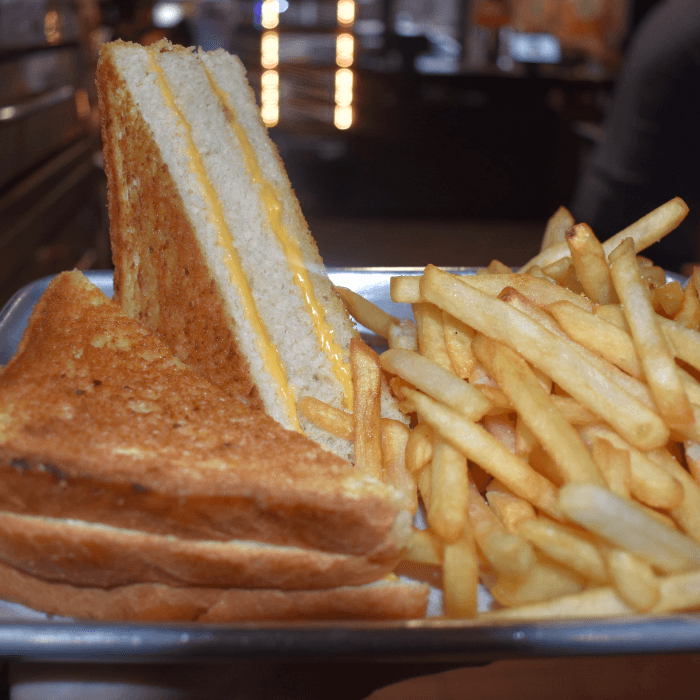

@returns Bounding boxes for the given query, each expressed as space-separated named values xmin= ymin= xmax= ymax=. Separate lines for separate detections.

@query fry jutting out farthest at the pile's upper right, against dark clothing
xmin=519 ymin=197 xmax=688 ymax=273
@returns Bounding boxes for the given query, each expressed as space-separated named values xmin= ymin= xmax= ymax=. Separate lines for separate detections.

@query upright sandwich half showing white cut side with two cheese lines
xmin=97 ymin=41 xmax=402 ymax=459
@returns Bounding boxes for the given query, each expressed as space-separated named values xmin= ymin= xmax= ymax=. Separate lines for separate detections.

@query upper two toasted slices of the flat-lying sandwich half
xmin=0 ymin=271 xmax=422 ymax=590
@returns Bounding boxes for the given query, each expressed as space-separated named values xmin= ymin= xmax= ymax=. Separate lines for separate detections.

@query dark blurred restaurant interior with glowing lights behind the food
xmin=0 ymin=0 xmax=694 ymax=303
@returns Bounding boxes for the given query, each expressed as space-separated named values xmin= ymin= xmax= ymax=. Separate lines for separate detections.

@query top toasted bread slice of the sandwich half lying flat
xmin=0 ymin=271 xmax=408 ymax=561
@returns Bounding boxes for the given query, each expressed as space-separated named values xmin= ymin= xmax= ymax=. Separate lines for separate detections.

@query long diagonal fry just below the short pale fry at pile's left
xmin=404 ymin=390 xmax=559 ymax=518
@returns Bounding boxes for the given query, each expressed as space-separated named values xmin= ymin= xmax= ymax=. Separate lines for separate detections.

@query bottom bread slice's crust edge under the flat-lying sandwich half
xmin=0 ymin=563 xmax=428 ymax=622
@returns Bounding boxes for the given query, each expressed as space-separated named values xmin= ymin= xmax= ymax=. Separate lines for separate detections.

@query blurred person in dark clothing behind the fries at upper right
xmin=569 ymin=0 xmax=700 ymax=271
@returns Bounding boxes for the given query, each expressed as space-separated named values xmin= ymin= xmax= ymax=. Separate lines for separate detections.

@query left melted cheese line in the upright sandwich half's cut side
xmin=148 ymin=51 xmax=301 ymax=432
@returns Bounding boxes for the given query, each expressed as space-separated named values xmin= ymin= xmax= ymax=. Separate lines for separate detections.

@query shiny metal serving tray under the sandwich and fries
xmin=0 ymin=268 xmax=700 ymax=660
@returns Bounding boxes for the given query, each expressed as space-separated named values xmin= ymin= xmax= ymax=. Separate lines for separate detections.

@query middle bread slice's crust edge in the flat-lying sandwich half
xmin=0 ymin=512 xmax=391 ymax=590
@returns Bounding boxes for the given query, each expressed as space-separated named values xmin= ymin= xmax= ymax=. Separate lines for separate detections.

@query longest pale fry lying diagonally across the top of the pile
xmin=421 ymin=265 xmax=669 ymax=449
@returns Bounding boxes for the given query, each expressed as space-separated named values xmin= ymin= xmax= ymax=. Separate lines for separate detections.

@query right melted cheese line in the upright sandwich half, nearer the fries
xmin=206 ymin=68 xmax=352 ymax=410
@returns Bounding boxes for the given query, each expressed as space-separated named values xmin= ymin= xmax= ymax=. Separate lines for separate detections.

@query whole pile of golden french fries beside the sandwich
xmin=308 ymin=199 xmax=700 ymax=621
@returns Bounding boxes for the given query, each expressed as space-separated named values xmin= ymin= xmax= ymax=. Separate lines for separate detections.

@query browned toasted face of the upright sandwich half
xmin=96 ymin=39 xmax=262 ymax=408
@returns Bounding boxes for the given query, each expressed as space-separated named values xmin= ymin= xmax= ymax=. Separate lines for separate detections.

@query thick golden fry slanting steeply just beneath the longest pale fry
xmin=474 ymin=336 xmax=603 ymax=485
